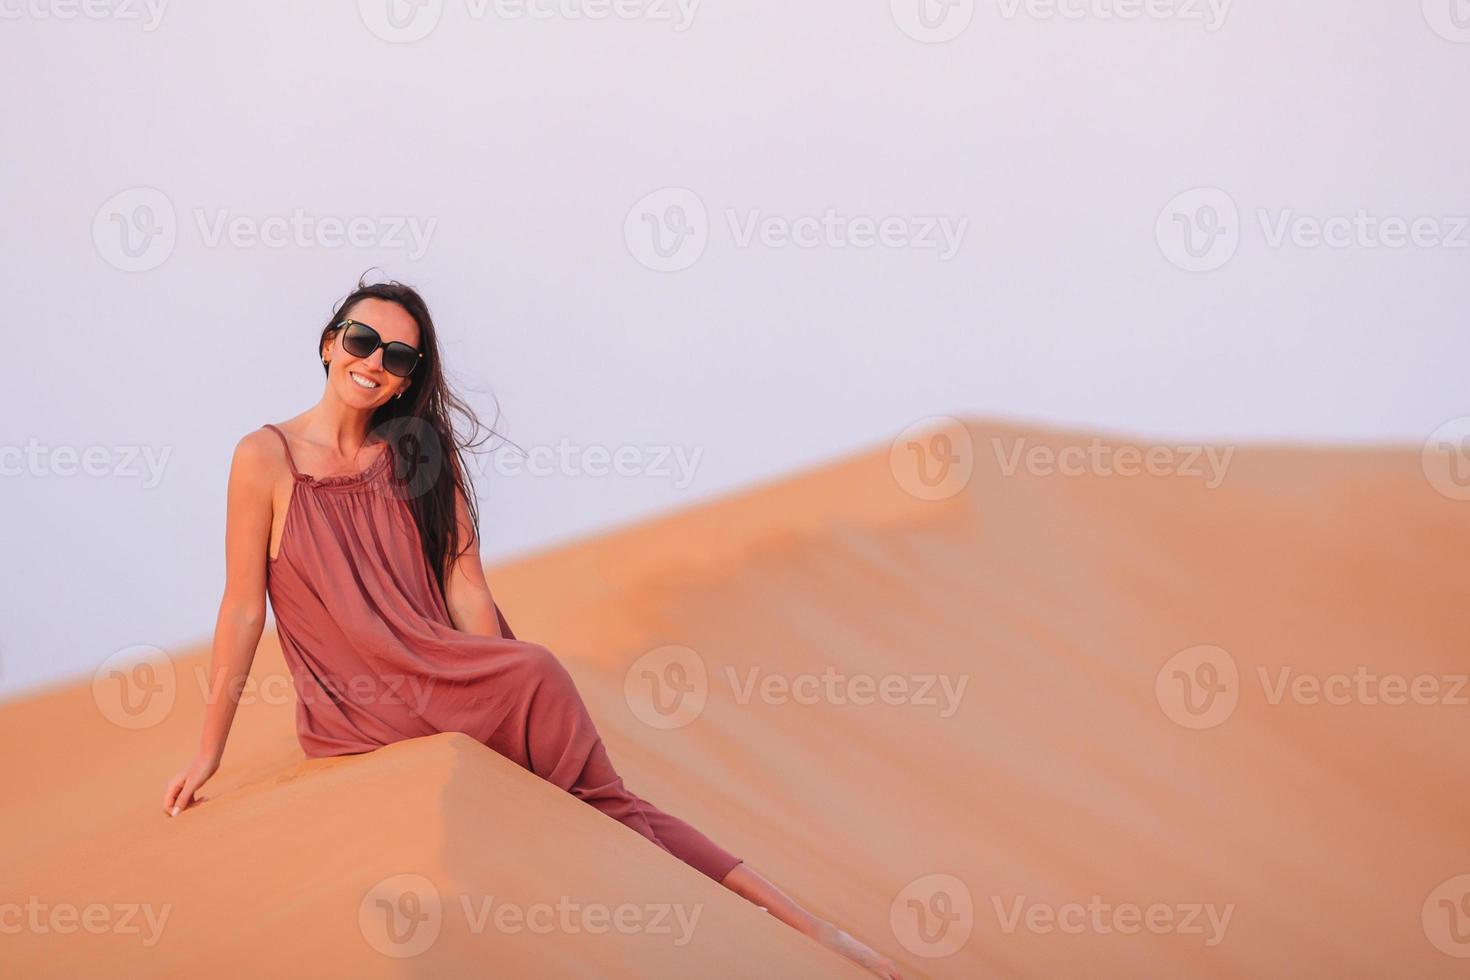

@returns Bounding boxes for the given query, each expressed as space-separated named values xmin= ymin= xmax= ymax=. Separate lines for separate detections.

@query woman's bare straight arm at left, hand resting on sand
xmin=163 ymin=429 xmax=276 ymax=815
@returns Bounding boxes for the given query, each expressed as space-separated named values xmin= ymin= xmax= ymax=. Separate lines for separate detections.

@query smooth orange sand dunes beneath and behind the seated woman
xmin=0 ymin=422 xmax=1470 ymax=977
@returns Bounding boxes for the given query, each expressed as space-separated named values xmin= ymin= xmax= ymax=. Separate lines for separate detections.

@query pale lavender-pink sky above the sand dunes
xmin=0 ymin=0 xmax=1470 ymax=693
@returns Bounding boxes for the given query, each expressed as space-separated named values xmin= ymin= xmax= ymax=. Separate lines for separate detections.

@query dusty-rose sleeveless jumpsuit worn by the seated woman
xmin=265 ymin=423 xmax=741 ymax=882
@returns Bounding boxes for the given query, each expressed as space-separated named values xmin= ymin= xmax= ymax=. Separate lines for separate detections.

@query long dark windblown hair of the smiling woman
xmin=316 ymin=275 xmax=520 ymax=595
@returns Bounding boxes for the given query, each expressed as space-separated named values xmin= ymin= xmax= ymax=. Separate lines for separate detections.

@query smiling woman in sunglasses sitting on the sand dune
xmin=163 ymin=282 xmax=900 ymax=980
